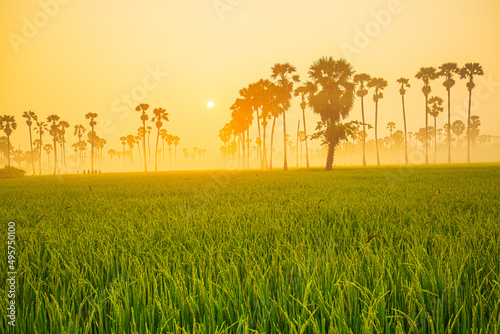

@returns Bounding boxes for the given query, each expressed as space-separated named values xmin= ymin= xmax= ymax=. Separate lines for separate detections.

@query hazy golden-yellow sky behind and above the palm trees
xmin=0 ymin=0 xmax=500 ymax=164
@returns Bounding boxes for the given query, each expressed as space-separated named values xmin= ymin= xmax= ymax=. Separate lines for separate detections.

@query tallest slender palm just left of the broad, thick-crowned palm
xmin=271 ymin=63 xmax=299 ymax=171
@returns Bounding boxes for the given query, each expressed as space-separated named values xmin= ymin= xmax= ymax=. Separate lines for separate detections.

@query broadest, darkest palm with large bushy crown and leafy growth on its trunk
xmin=309 ymin=57 xmax=355 ymax=170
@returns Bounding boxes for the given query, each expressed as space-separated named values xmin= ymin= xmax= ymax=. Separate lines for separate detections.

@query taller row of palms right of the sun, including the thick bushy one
xmin=219 ymin=57 xmax=491 ymax=171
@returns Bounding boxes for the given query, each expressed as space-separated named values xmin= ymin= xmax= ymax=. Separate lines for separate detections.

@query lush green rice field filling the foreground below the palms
xmin=0 ymin=165 xmax=500 ymax=333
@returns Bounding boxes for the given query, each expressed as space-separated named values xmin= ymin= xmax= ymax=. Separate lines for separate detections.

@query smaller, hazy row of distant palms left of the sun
xmin=0 ymin=103 xmax=211 ymax=175
